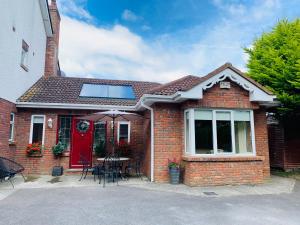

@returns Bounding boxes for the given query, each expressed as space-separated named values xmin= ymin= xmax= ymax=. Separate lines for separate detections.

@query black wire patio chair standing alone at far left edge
xmin=0 ymin=157 xmax=25 ymax=188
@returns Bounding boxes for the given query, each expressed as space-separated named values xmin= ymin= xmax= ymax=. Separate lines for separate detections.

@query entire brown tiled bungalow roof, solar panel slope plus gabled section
xmin=18 ymin=63 xmax=272 ymax=106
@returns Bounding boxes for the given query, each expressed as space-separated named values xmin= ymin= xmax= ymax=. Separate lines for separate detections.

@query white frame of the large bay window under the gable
xmin=184 ymin=108 xmax=256 ymax=157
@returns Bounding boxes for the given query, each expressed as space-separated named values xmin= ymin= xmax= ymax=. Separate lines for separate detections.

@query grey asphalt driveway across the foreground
xmin=0 ymin=183 xmax=300 ymax=225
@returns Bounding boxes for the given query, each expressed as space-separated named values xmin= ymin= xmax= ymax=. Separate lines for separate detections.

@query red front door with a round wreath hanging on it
xmin=70 ymin=118 xmax=94 ymax=168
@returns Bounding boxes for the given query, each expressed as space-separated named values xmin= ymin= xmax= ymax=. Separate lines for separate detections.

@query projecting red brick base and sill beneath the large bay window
xmin=184 ymin=157 xmax=263 ymax=186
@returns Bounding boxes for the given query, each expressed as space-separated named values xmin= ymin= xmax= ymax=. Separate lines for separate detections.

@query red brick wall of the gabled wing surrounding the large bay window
xmin=154 ymin=82 xmax=270 ymax=186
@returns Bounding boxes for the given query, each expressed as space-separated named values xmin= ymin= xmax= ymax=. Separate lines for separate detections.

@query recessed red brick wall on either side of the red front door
xmin=11 ymin=109 xmax=147 ymax=174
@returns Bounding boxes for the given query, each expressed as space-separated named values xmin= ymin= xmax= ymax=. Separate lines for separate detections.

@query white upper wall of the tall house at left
xmin=0 ymin=0 xmax=47 ymax=102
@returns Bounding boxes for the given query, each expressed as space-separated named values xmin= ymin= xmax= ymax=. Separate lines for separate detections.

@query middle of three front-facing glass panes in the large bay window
xmin=216 ymin=112 xmax=232 ymax=153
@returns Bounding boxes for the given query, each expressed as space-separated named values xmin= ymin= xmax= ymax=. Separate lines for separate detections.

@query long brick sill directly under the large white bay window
xmin=182 ymin=155 xmax=265 ymax=162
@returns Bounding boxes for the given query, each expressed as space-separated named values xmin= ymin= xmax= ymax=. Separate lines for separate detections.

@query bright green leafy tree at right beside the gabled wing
xmin=245 ymin=18 xmax=300 ymax=119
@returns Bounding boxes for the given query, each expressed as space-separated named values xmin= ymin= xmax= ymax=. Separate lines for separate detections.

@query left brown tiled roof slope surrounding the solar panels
xmin=18 ymin=77 xmax=159 ymax=106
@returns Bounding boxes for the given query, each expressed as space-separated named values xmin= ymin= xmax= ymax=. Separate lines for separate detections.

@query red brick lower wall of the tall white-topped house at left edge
xmin=0 ymin=98 xmax=17 ymax=158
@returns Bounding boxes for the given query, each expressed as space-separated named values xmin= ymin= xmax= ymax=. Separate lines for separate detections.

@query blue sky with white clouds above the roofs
xmin=57 ymin=0 xmax=300 ymax=82
